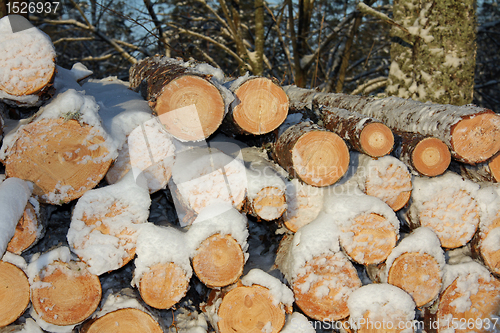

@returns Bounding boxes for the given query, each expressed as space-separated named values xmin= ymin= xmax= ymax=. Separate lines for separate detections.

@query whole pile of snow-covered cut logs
xmin=0 ymin=21 xmax=500 ymax=333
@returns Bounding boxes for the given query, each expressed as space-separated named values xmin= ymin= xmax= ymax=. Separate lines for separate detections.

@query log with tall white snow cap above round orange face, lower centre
xmin=187 ymin=205 xmax=248 ymax=288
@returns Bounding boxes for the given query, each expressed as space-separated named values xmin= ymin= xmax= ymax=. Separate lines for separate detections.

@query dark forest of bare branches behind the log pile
xmin=3 ymin=0 xmax=500 ymax=111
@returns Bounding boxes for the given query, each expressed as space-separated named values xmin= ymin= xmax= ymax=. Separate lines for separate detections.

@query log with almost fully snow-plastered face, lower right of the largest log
xmin=67 ymin=172 xmax=151 ymax=275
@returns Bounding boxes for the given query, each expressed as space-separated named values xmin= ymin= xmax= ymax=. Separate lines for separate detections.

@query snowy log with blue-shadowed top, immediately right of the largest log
xmin=83 ymin=78 xmax=175 ymax=193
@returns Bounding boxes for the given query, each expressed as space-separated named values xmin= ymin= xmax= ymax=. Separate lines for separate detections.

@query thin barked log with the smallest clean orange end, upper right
xmin=313 ymin=101 xmax=394 ymax=157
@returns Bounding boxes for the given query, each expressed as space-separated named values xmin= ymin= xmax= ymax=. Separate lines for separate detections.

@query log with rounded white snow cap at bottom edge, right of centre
xmin=347 ymin=283 xmax=415 ymax=333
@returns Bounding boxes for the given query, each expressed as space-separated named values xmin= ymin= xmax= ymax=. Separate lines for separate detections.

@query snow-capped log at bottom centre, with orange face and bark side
xmin=204 ymin=269 xmax=293 ymax=333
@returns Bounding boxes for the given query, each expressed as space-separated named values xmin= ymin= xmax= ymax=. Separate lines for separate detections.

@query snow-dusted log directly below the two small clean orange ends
xmin=345 ymin=152 xmax=412 ymax=211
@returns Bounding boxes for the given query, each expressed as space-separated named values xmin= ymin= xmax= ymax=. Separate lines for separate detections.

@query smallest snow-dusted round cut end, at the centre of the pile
xmin=252 ymin=186 xmax=287 ymax=221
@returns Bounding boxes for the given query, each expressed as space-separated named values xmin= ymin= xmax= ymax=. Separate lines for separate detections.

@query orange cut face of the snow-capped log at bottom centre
xmin=217 ymin=285 xmax=285 ymax=333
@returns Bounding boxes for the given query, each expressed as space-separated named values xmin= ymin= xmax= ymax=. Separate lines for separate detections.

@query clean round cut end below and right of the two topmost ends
xmin=292 ymin=131 xmax=349 ymax=186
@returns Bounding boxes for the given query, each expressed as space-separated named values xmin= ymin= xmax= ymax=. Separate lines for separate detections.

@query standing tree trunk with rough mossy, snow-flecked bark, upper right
xmin=386 ymin=0 xmax=476 ymax=105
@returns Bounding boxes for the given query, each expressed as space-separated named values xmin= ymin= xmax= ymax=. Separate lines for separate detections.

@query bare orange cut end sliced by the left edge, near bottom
xmin=0 ymin=261 xmax=30 ymax=327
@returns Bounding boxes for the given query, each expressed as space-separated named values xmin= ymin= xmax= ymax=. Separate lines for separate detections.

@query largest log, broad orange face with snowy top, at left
xmin=0 ymin=89 xmax=116 ymax=205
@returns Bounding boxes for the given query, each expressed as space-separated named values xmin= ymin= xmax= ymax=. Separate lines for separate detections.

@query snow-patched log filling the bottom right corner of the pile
xmin=424 ymin=258 xmax=500 ymax=333
